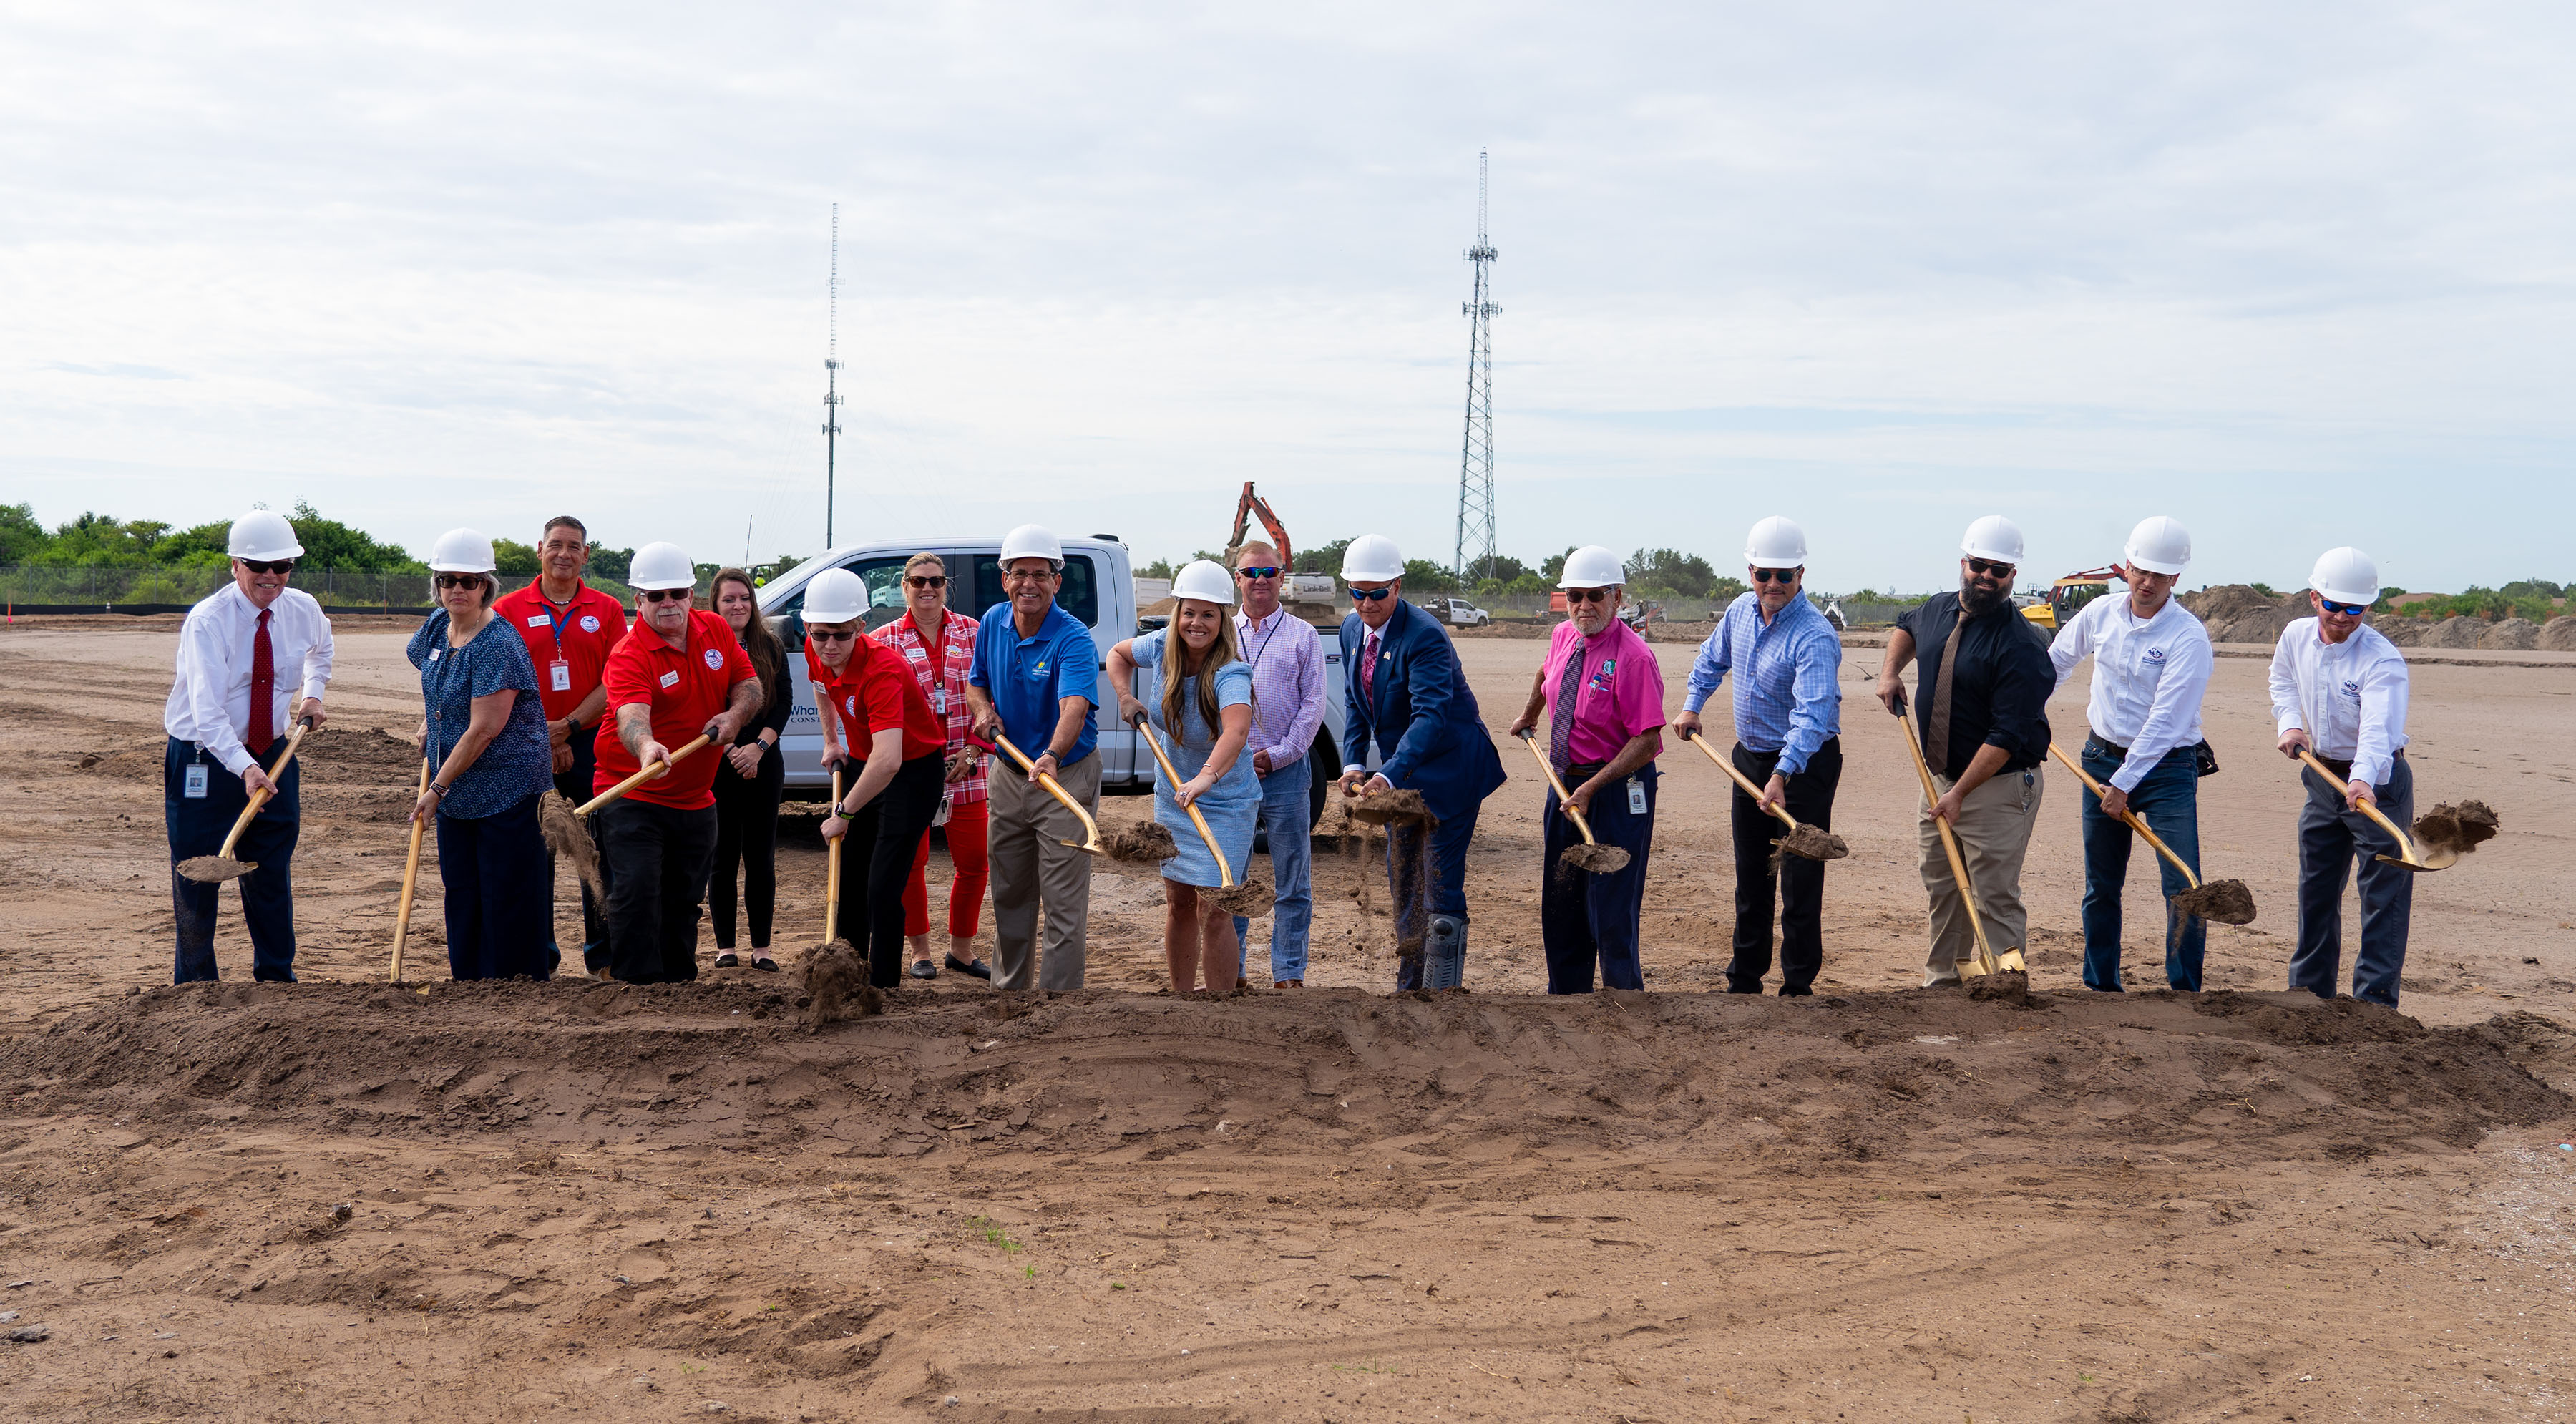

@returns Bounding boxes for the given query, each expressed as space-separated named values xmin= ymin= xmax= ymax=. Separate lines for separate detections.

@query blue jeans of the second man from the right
xmin=2084 ymin=736 xmax=2210 ymax=994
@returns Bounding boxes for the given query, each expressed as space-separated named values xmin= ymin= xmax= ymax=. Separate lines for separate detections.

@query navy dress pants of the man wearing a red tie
xmin=162 ymin=736 xmax=304 ymax=984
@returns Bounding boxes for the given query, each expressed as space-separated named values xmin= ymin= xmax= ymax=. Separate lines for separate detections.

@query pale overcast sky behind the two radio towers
xmin=0 ymin=0 xmax=2576 ymax=590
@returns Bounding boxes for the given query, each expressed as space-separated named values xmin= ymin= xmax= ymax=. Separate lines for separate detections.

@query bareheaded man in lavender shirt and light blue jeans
xmin=1234 ymin=543 xmax=1324 ymax=989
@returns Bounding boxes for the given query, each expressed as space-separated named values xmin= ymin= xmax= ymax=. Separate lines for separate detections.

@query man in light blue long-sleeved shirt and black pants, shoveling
xmin=1672 ymin=515 xmax=1842 ymax=999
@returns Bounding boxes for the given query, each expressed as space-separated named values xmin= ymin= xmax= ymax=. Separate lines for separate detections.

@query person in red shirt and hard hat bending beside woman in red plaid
xmin=804 ymin=569 xmax=948 ymax=989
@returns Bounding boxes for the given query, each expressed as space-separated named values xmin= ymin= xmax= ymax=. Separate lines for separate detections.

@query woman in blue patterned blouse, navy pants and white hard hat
xmin=407 ymin=528 xmax=554 ymax=978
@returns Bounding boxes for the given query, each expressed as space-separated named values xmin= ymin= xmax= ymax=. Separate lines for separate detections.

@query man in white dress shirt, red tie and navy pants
xmin=162 ymin=510 xmax=332 ymax=984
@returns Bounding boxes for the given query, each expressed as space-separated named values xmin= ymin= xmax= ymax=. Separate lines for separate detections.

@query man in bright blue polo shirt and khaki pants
xmin=966 ymin=525 xmax=1100 ymax=991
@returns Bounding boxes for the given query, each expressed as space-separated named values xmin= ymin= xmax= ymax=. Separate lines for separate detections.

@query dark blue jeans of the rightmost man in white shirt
xmin=2290 ymin=757 xmax=2416 ymax=1010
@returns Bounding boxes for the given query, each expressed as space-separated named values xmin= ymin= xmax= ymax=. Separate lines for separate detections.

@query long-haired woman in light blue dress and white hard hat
xmin=1111 ymin=559 xmax=1262 ymax=994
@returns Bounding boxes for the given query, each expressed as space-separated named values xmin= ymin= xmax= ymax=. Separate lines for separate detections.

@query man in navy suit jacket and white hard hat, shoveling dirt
xmin=1342 ymin=533 xmax=1510 ymax=989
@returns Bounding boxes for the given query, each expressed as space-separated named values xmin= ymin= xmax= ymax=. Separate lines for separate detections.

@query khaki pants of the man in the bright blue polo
xmin=984 ymin=749 xmax=1100 ymax=991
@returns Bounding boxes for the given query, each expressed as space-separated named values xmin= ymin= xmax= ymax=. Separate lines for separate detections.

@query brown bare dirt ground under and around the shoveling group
xmin=0 ymin=620 xmax=2576 ymax=1424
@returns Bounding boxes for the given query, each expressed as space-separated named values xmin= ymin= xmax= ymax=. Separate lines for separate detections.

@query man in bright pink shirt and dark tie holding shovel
xmin=1512 ymin=543 xmax=1664 ymax=994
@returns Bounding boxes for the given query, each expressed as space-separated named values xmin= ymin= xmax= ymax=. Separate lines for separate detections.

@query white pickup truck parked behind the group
xmin=760 ymin=533 xmax=1375 ymax=816
